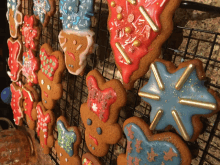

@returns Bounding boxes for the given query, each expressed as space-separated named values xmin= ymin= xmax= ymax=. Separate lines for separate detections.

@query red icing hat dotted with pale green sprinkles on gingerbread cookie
xmin=40 ymin=48 xmax=59 ymax=81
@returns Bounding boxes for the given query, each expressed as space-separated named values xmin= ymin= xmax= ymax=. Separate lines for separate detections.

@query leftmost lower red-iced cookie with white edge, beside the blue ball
xmin=10 ymin=82 xmax=23 ymax=126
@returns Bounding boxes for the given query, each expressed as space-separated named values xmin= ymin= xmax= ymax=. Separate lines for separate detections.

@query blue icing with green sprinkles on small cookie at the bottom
xmin=57 ymin=120 xmax=76 ymax=156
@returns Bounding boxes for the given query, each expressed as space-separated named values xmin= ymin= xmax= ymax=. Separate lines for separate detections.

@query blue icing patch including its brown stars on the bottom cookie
xmin=124 ymin=123 xmax=181 ymax=165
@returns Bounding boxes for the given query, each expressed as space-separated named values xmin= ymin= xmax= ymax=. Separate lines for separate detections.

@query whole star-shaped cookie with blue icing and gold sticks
xmin=138 ymin=60 xmax=220 ymax=141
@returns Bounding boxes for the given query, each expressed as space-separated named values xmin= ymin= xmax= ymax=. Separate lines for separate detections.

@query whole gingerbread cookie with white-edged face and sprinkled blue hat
xmin=59 ymin=0 xmax=94 ymax=75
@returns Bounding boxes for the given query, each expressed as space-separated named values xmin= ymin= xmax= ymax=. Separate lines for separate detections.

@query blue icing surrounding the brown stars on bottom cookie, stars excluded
xmin=124 ymin=123 xmax=181 ymax=165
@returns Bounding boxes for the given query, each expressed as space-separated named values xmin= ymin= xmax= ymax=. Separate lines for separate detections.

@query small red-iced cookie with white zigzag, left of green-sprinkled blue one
xmin=32 ymin=102 xmax=55 ymax=154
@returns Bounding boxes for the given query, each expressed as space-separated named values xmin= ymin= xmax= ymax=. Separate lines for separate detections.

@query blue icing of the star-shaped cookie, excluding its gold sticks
xmin=140 ymin=62 xmax=216 ymax=138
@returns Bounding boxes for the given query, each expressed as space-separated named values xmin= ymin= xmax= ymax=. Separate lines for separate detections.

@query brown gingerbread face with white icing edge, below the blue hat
xmin=59 ymin=30 xmax=94 ymax=75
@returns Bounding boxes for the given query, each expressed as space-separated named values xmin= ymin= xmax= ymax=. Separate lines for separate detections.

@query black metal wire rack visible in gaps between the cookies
xmin=8 ymin=0 xmax=220 ymax=165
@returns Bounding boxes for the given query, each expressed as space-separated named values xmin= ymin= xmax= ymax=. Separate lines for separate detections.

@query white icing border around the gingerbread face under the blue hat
xmin=58 ymin=30 xmax=95 ymax=75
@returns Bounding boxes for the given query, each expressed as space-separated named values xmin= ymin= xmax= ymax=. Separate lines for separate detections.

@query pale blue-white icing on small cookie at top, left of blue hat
xmin=33 ymin=0 xmax=50 ymax=23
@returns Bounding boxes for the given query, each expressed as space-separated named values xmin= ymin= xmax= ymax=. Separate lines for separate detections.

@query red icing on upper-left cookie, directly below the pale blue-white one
xmin=22 ymin=16 xmax=38 ymax=50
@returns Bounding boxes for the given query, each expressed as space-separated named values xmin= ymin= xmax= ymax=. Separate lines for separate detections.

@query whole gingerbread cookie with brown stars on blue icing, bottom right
xmin=117 ymin=117 xmax=191 ymax=165
